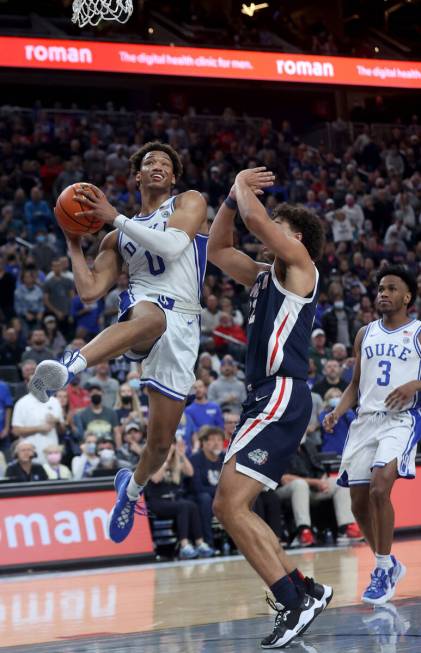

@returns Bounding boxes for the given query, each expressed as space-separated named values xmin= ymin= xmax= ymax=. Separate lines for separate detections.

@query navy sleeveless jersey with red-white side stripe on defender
xmin=246 ymin=266 xmax=319 ymax=387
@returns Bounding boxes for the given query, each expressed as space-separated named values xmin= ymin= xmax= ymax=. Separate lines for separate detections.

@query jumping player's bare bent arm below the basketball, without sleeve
xmin=66 ymin=231 xmax=122 ymax=303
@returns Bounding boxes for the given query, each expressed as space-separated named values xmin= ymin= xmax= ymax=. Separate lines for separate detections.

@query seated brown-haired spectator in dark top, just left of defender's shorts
xmin=190 ymin=426 xmax=225 ymax=547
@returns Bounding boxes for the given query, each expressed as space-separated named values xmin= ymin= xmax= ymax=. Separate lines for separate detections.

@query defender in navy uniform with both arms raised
xmin=209 ymin=168 xmax=332 ymax=648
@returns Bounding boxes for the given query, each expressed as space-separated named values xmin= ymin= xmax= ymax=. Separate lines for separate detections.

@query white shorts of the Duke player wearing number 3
xmin=337 ymin=409 xmax=421 ymax=487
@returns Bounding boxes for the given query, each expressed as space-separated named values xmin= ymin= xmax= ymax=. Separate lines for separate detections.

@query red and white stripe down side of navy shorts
xmin=224 ymin=377 xmax=293 ymax=462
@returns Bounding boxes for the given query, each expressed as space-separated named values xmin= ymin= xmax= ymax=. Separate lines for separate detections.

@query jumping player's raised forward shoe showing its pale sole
xmin=28 ymin=349 xmax=83 ymax=404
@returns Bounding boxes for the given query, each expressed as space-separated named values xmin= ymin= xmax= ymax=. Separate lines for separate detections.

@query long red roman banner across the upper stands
xmin=0 ymin=36 xmax=421 ymax=88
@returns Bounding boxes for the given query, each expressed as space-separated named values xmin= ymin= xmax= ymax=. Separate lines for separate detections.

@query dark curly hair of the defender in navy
xmin=272 ymin=203 xmax=325 ymax=261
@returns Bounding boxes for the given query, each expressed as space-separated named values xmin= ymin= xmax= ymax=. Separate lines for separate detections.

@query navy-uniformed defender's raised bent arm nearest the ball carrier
xmin=208 ymin=187 xmax=270 ymax=286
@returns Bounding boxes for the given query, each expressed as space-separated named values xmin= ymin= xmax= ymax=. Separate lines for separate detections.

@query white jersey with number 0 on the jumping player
xmin=117 ymin=197 xmax=208 ymax=314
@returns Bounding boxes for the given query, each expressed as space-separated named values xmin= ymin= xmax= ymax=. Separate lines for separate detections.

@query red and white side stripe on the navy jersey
xmin=266 ymin=297 xmax=303 ymax=376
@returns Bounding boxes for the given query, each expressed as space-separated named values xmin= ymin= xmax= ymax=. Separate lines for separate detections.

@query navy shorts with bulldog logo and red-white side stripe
xmin=224 ymin=377 xmax=312 ymax=490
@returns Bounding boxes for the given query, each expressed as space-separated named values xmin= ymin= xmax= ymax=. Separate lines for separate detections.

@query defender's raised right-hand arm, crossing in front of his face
xmin=235 ymin=168 xmax=314 ymax=270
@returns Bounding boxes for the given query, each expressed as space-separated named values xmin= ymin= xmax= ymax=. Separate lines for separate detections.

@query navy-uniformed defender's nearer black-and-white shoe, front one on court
xmin=260 ymin=594 xmax=323 ymax=648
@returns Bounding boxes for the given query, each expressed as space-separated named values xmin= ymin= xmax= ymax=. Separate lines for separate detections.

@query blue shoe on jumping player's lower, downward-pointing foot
xmin=108 ymin=469 xmax=146 ymax=543
